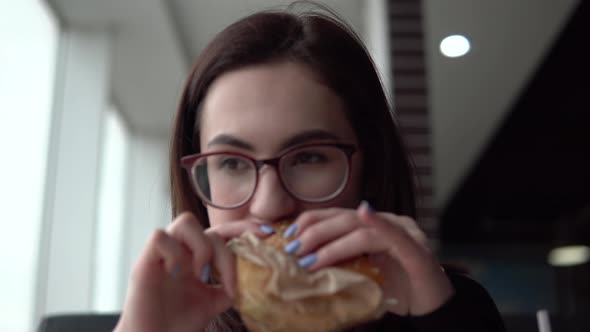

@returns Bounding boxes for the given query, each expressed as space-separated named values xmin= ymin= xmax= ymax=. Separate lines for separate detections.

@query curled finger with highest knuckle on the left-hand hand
xmin=167 ymin=212 xmax=213 ymax=278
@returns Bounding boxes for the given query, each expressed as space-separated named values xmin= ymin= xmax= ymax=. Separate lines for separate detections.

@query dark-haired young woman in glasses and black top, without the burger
xmin=117 ymin=4 xmax=504 ymax=332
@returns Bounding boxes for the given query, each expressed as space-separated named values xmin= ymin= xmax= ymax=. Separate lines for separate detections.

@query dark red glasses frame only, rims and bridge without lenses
xmin=180 ymin=143 xmax=357 ymax=210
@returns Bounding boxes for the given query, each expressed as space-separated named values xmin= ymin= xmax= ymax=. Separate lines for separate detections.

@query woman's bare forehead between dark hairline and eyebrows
xmin=201 ymin=62 xmax=356 ymax=150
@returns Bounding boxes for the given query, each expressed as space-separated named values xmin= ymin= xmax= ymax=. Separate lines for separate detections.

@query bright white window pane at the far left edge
xmin=0 ymin=0 xmax=58 ymax=331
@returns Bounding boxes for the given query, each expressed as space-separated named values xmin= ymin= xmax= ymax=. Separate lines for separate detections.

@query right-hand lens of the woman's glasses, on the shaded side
xmin=280 ymin=146 xmax=349 ymax=201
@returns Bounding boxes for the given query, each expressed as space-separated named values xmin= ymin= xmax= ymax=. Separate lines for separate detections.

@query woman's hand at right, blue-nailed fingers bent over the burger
xmin=287 ymin=203 xmax=454 ymax=315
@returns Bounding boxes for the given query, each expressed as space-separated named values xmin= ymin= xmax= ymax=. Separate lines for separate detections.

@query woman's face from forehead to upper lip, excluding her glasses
xmin=200 ymin=62 xmax=362 ymax=226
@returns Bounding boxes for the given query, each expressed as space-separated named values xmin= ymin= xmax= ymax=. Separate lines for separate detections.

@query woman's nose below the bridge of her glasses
xmin=249 ymin=165 xmax=297 ymax=222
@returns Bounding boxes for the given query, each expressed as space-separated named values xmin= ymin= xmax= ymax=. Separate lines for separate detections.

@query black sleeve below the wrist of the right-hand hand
xmin=407 ymin=273 xmax=506 ymax=332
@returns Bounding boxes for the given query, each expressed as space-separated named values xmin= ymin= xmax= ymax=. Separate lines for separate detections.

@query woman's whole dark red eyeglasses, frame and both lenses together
xmin=181 ymin=143 xmax=356 ymax=209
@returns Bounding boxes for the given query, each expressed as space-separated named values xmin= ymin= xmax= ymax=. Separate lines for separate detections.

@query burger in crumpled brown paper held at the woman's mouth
xmin=229 ymin=221 xmax=383 ymax=332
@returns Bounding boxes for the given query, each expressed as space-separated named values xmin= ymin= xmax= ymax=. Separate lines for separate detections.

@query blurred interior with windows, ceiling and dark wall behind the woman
xmin=0 ymin=0 xmax=590 ymax=331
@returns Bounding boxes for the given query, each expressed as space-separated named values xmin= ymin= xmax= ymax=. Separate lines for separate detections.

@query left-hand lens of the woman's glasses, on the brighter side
xmin=193 ymin=154 xmax=256 ymax=208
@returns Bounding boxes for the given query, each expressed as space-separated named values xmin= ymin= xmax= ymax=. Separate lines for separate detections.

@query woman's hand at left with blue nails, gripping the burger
xmin=115 ymin=213 xmax=264 ymax=332
